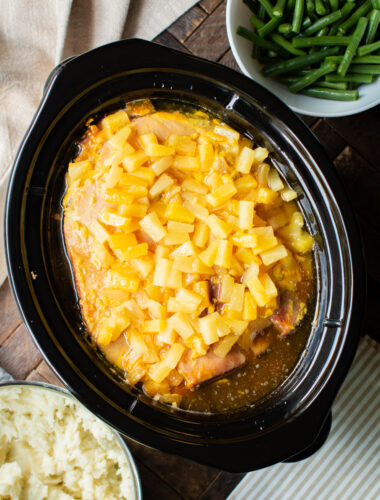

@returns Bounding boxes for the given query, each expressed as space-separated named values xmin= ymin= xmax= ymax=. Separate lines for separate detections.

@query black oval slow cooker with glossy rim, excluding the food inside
xmin=5 ymin=39 xmax=365 ymax=472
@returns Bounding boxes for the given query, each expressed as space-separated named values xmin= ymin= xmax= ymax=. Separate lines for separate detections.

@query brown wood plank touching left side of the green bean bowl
xmin=184 ymin=2 xmax=229 ymax=61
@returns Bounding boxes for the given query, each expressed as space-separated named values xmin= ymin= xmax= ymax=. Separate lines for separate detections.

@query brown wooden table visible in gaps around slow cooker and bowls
xmin=0 ymin=0 xmax=380 ymax=500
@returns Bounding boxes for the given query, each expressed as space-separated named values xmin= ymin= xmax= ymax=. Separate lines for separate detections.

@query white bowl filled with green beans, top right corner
xmin=226 ymin=0 xmax=380 ymax=117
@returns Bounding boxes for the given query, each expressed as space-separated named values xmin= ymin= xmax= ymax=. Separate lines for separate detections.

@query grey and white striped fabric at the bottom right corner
xmin=228 ymin=337 xmax=380 ymax=500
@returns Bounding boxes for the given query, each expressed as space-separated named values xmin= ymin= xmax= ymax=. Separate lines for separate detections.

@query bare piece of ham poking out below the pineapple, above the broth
xmin=178 ymin=348 xmax=246 ymax=388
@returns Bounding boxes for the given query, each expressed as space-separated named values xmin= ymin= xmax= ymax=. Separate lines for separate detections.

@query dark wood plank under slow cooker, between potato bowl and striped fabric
xmin=126 ymin=439 xmax=219 ymax=500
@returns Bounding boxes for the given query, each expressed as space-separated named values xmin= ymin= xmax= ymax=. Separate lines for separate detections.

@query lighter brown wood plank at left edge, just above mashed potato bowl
xmin=0 ymin=324 xmax=42 ymax=380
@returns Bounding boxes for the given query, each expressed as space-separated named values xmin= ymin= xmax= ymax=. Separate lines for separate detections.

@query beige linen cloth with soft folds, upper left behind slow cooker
xmin=0 ymin=0 xmax=197 ymax=285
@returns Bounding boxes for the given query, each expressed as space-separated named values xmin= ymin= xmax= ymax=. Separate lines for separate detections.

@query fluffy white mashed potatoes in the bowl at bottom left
xmin=0 ymin=386 xmax=136 ymax=500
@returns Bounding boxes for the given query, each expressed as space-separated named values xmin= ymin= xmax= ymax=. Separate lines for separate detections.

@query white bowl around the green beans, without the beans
xmin=226 ymin=0 xmax=380 ymax=117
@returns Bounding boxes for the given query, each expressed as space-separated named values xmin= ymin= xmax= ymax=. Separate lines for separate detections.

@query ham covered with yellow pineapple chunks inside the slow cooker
xmin=63 ymin=102 xmax=313 ymax=405
